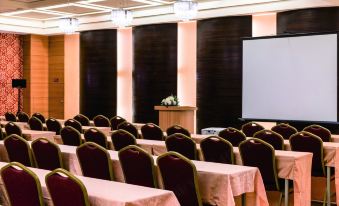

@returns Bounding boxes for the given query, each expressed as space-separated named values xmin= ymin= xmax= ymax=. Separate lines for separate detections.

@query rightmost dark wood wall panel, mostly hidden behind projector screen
xmin=277 ymin=7 xmax=339 ymax=134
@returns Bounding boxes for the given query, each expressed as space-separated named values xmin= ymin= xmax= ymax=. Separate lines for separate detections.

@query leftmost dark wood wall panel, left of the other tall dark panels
xmin=80 ymin=30 xmax=117 ymax=118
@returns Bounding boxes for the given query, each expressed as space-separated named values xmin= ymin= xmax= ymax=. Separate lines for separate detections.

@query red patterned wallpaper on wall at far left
xmin=0 ymin=33 xmax=23 ymax=115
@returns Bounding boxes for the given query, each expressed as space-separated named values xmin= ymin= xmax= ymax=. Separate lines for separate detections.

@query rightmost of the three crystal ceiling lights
xmin=173 ymin=0 xmax=198 ymax=21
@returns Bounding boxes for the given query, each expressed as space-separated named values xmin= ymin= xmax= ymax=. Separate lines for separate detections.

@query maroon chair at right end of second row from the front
xmin=157 ymin=152 xmax=203 ymax=206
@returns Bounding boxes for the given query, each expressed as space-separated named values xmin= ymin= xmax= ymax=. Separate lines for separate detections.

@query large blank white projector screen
xmin=242 ymin=34 xmax=338 ymax=122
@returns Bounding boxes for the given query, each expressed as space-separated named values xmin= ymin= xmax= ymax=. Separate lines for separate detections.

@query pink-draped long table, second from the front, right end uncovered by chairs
xmin=0 ymin=141 xmax=268 ymax=206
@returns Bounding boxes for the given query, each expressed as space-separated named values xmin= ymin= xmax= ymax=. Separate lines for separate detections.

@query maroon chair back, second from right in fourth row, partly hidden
xmin=253 ymin=129 xmax=284 ymax=150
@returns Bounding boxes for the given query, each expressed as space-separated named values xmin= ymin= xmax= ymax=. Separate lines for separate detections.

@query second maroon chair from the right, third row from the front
xmin=200 ymin=136 xmax=234 ymax=164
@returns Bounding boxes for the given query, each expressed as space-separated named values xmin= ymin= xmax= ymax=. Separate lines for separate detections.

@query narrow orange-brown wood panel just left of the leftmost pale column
xmin=48 ymin=35 xmax=65 ymax=119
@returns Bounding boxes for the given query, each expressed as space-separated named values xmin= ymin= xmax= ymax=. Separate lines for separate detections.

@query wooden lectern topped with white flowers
xmin=154 ymin=106 xmax=197 ymax=134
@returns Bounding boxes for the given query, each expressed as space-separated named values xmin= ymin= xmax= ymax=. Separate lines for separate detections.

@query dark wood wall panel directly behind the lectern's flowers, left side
xmin=133 ymin=23 xmax=178 ymax=123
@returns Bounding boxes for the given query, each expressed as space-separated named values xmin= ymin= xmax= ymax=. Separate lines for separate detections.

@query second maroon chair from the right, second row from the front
xmin=119 ymin=145 xmax=157 ymax=188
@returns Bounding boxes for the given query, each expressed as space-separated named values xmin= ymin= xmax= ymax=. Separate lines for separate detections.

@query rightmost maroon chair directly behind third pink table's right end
xmin=290 ymin=131 xmax=325 ymax=177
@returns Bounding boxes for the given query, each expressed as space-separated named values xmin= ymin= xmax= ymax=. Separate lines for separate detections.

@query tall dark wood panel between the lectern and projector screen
xmin=197 ymin=16 xmax=252 ymax=131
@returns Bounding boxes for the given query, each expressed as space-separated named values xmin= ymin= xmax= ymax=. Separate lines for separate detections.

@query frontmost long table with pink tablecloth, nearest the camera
xmin=0 ymin=162 xmax=180 ymax=206
